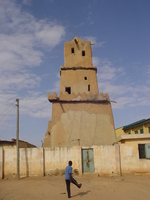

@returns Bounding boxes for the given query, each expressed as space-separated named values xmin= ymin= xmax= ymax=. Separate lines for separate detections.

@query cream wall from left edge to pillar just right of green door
xmin=0 ymin=145 xmax=117 ymax=178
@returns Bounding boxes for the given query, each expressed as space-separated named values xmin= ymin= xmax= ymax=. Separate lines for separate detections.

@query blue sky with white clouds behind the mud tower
xmin=0 ymin=0 xmax=150 ymax=146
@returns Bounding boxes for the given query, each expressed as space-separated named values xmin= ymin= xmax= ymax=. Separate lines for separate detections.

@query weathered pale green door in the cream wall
xmin=82 ymin=149 xmax=94 ymax=173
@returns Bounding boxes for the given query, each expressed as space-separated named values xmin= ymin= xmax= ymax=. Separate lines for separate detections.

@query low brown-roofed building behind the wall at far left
xmin=0 ymin=138 xmax=36 ymax=148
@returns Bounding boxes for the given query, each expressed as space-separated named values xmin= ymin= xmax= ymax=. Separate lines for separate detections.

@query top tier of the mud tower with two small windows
xmin=64 ymin=36 xmax=93 ymax=68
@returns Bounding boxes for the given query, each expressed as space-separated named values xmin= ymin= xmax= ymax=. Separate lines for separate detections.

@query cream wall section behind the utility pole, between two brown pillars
xmin=0 ymin=148 xmax=44 ymax=177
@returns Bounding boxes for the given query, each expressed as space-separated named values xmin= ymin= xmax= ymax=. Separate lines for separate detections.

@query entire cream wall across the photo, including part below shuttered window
xmin=0 ymin=142 xmax=150 ymax=178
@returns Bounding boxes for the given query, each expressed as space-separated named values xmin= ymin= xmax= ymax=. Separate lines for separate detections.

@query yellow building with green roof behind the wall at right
xmin=116 ymin=118 xmax=150 ymax=137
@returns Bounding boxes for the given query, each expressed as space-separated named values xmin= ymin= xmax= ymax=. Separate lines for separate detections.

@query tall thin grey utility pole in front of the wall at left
xmin=16 ymin=99 xmax=20 ymax=180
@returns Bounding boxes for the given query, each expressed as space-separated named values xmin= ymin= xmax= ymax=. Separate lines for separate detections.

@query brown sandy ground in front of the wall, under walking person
xmin=0 ymin=175 xmax=150 ymax=200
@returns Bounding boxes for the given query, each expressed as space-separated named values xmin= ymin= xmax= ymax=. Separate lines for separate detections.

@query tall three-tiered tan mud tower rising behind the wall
xmin=43 ymin=37 xmax=116 ymax=147
